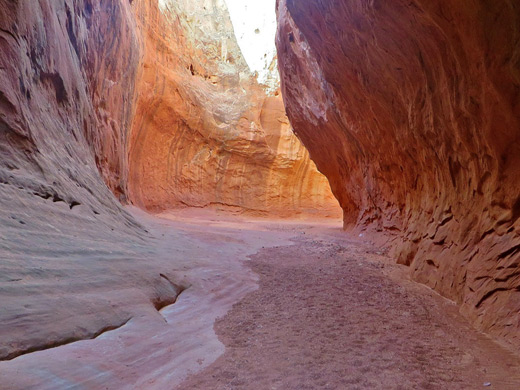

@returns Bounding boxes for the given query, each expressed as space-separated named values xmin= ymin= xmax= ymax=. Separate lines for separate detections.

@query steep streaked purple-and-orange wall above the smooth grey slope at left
xmin=0 ymin=0 xmax=139 ymax=204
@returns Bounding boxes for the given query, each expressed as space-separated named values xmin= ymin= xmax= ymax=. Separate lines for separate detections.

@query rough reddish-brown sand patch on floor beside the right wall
xmin=178 ymin=224 xmax=520 ymax=390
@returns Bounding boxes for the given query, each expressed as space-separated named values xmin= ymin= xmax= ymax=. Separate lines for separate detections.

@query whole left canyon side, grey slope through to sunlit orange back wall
xmin=0 ymin=0 xmax=336 ymax=360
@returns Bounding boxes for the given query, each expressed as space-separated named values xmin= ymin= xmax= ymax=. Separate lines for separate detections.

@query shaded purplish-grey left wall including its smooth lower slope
xmin=0 ymin=0 xmax=150 ymax=360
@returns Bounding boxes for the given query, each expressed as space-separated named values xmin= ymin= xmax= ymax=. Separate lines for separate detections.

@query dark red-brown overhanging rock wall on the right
xmin=277 ymin=0 xmax=520 ymax=346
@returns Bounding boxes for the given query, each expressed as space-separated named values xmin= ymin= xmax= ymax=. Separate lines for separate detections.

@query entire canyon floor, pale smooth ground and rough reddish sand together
xmin=0 ymin=209 xmax=520 ymax=390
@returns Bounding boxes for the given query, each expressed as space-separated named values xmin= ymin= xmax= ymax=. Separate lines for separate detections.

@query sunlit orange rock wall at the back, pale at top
xmin=125 ymin=0 xmax=339 ymax=216
